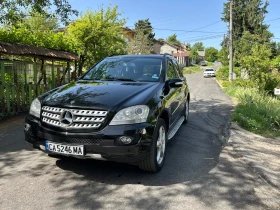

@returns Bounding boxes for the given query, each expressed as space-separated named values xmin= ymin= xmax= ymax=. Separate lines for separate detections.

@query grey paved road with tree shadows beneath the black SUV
xmin=0 ymin=72 xmax=272 ymax=210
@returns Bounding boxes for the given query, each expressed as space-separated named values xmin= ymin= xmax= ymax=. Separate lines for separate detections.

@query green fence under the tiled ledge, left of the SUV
xmin=0 ymin=60 xmax=71 ymax=119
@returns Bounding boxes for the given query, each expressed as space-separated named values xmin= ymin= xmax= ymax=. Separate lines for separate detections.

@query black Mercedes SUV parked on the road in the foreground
xmin=25 ymin=54 xmax=190 ymax=172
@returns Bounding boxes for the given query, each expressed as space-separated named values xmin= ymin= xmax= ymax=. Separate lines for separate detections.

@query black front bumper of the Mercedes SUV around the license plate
xmin=25 ymin=115 xmax=154 ymax=163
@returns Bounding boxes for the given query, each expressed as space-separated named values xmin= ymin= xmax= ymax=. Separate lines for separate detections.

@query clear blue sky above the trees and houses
xmin=68 ymin=0 xmax=280 ymax=49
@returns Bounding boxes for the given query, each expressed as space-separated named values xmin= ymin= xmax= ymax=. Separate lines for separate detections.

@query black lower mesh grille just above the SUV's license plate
xmin=38 ymin=131 xmax=102 ymax=145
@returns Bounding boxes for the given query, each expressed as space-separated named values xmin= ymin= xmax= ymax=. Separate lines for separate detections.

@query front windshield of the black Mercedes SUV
xmin=81 ymin=57 xmax=162 ymax=82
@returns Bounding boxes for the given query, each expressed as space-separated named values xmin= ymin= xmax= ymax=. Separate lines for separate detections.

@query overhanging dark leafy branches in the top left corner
xmin=0 ymin=0 xmax=78 ymax=24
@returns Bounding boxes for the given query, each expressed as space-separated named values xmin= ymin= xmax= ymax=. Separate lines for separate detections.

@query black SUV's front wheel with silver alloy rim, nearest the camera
xmin=139 ymin=118 xmax=167 ymax=173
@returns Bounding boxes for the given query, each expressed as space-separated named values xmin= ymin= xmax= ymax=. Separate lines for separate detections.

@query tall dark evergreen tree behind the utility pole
xmin=222 ymin=0 xmax=273 ymax=66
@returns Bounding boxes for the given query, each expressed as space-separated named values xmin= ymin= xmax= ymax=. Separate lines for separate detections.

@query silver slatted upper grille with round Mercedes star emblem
xmin=42 ymin=106 xmax=107 ymax=129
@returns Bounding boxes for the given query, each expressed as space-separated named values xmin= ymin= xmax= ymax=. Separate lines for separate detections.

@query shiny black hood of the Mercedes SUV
xmin=43 ymin=81 xmax=159 ymax=110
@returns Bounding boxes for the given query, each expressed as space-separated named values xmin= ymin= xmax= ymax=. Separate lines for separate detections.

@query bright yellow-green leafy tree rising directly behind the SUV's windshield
xmin=67 ymin=6 xmax=126 ymax=75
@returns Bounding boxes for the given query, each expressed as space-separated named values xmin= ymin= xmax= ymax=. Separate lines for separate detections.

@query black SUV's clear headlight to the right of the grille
xmin=110 ymin=105 xmax=149 ymax=125
